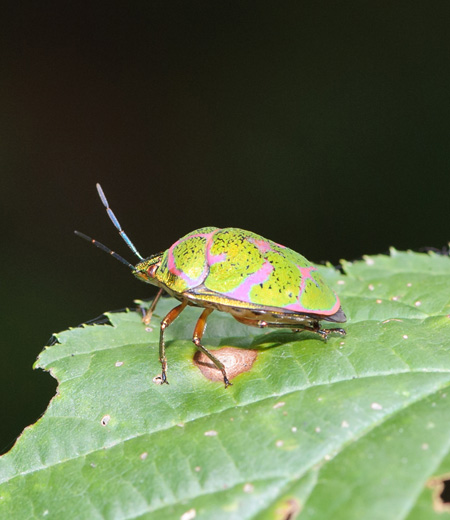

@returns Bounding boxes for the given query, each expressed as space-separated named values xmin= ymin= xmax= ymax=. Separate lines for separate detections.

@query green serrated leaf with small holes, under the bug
xmin=0 ymin=250 xmax=450 ymax=520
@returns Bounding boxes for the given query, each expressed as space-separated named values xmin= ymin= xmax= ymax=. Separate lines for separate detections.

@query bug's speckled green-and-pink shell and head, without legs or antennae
xmin=142 ymin=227 xmax=345 ymax=322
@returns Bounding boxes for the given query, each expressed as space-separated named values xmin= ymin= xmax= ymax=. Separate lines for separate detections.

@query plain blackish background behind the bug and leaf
xmin=0 ymin=1 xmax=450 ymax=451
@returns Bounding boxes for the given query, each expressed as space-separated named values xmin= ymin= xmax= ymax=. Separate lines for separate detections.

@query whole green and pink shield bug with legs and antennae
xmin=75 ymin=184 xmax=346 ymax=388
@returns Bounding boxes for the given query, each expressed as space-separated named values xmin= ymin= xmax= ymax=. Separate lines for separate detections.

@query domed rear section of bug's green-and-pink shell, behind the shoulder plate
xmin=200 ymin=228 xmax=340 ymax=315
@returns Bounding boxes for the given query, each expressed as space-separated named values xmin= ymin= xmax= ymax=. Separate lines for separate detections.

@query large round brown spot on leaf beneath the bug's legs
xmin=194 ymin=347 xmax=258 ymax=381
